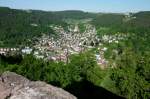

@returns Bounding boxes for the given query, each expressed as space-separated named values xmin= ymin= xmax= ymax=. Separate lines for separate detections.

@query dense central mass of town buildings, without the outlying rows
xmin=29 ymin=24 xmax=99 ymax=62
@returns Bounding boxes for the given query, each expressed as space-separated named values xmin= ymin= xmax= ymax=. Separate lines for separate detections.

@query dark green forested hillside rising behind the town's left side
xmin=0 ymin=7 xmax=94 ymax=46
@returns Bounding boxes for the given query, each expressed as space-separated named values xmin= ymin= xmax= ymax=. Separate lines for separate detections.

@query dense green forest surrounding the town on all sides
xmin=0 ymin=7 xmax=150 ymax=99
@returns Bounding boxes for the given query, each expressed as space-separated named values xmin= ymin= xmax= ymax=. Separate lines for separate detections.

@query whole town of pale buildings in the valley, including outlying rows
xmin=0 ymin=24 xmax=125 ymax=68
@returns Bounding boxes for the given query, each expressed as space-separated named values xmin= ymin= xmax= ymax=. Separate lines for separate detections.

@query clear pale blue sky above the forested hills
xmin=0 ymin=0 xmax=150 ymax=12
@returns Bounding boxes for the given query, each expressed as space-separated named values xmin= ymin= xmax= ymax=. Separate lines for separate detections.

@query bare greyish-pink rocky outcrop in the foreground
xmin=0 ymin=72 xmax=76 ymax=99
